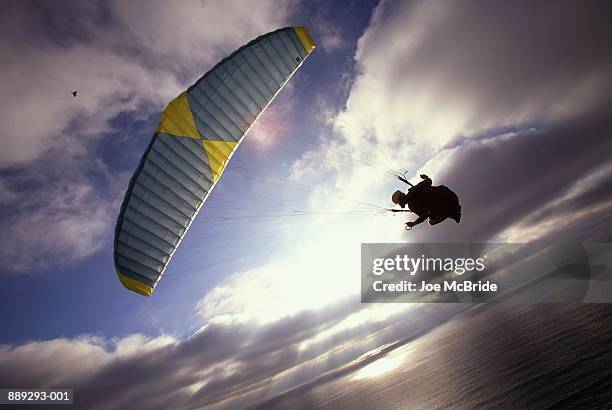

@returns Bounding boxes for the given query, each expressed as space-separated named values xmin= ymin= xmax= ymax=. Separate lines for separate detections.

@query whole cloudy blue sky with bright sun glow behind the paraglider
xmin=0 ymin=0 xmax=612 ymax=409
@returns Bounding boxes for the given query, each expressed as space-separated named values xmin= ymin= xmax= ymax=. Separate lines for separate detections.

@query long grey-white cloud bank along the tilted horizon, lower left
xmin=0 ymin=303 xmax=456 ymax=409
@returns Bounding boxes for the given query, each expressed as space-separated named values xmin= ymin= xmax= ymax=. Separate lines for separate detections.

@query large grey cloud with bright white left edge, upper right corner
xmin=341 ymin=1 xmax=612 ymax=159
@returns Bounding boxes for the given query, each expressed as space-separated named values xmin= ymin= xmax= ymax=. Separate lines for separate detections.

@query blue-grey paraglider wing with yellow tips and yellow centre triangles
xmin=114 ymin=27 xmax=315 ymax=296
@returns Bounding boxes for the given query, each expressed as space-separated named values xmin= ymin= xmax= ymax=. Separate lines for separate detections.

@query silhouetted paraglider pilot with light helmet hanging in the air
xmin=391 ymin=174 xmax=461 ymax=228
